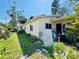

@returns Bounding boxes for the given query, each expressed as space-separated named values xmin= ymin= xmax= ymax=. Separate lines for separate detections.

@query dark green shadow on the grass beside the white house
xmin=17 ymin=32 xmax=43 ymax=55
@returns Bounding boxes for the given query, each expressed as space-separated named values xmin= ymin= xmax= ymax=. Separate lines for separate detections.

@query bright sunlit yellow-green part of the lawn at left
xmin=0 ymin=33 xmax=23 ymax=59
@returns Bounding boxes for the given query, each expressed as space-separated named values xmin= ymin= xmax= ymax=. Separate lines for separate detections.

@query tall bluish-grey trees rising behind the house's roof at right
xmin=51 ymin=0 xmax=70 ymax=17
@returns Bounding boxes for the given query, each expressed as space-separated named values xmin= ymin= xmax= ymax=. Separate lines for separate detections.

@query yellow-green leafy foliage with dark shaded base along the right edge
xmin=64 ymin=4 xmax=79 ymax=42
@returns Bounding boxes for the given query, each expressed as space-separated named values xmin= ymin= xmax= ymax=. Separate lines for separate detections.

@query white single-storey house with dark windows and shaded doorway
xmin=25 ymin=16 xmax=63 ymax=46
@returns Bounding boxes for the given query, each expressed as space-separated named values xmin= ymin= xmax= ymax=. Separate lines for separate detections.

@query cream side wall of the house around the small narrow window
xmin=25 ymin=20 xmax=39 ymax=37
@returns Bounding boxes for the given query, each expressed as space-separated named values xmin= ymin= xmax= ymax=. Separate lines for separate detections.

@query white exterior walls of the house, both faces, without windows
xmin=25 ymin=17 xmax=61 ymax=46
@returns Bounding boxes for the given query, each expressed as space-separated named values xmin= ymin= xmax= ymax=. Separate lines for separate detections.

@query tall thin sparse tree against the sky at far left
xmin=7 ymin=1 xmax=17 ymax=28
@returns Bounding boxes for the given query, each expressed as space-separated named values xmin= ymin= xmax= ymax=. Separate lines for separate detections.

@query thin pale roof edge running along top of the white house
xmin=26 ymin=16 xmax=64 ymax=24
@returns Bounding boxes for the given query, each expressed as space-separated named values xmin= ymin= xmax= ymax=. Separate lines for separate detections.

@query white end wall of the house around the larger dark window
xmin=39 ymin=18 xmax=53 ymax=46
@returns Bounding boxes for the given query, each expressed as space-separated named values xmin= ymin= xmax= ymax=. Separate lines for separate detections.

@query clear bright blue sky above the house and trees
xmin=0 ymin=0 xmax=64 ymax=22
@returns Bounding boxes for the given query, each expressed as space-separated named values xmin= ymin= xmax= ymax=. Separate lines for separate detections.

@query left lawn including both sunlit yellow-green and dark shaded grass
xmin=0 ymin=33 xmax=42 ymax=59
